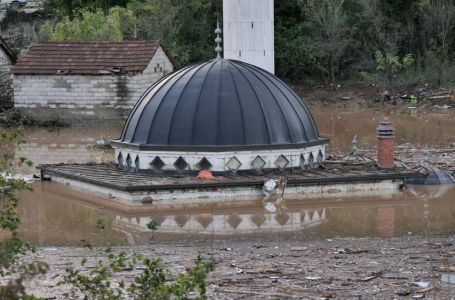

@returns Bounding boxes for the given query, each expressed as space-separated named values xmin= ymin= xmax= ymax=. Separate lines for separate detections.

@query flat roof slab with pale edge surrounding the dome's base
xmin=40 ymin=165 xmax=413 ymax=205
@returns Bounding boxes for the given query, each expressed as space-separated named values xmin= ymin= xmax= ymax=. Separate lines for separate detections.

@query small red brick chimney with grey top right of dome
xmin=377 ymin=122 xmax=395 ymax=169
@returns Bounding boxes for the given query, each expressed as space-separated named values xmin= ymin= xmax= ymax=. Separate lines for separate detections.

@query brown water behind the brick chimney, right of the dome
xmin=311 ymin=107 xmax=455 ymax=149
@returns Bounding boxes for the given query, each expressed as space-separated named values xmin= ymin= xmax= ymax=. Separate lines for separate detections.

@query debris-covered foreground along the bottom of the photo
xmin=27 ymin=235 xmax=455 ymax=299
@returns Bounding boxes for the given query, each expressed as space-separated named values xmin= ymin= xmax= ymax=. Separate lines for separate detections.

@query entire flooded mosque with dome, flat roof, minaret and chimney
xmin=41 ymin=0 xmax=412 ymax=203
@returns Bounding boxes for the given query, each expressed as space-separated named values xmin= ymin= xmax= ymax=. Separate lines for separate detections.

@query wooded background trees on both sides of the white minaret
xmin=37 ymin=0 xmax=455 ymax=85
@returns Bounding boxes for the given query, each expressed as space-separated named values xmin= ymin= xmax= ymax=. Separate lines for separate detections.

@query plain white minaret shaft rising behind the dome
xmin=223 ymin=0 xmax=275 ymax=73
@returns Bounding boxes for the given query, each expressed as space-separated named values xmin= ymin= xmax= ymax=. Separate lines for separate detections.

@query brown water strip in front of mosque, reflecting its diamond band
xmin=16 ymin=182 xmax=455 ymax=245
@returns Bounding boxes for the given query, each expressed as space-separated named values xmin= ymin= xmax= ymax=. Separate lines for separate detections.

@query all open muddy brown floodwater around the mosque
xmin=15 ymin=107 xmax=455 ymax=246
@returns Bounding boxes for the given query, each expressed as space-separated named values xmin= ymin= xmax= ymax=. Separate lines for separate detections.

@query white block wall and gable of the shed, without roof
xmin=13 ymin=47 xmax=173 ymax=125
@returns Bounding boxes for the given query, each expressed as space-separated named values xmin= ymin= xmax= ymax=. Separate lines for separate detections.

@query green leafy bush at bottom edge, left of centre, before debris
xmin=59 ymin=250 xmax=214 ymax=300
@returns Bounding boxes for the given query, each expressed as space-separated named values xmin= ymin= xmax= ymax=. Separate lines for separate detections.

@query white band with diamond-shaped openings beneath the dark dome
xmin=114 ymin=144 xmax=326 ymax=174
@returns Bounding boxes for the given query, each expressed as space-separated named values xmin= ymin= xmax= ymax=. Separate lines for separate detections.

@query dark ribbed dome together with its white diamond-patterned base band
xmin=112 ymin=57 xmax=329 ymax=173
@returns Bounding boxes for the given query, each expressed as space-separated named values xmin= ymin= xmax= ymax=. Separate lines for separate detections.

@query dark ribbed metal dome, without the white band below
xmin=114 ymin=59 xmax=328 ymax=151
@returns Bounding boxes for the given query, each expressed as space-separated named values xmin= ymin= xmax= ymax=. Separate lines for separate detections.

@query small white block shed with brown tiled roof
xmin=12 ymin=41 xmax=174 ymax=125
